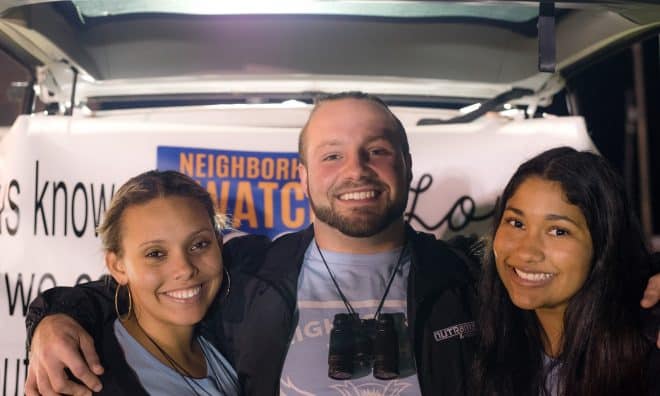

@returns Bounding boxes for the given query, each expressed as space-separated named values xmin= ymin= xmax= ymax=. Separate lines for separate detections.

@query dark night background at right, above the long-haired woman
xmin=567 ymin=36 xmax=660 ymax=238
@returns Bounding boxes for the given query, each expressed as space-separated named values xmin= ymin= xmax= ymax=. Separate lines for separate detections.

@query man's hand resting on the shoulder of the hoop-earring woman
xmin=25 ymin=314 xmax=103 ymax=396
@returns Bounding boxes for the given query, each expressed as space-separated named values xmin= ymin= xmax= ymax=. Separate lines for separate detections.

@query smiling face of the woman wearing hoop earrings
xmin=106 ymin=196 xmax=222 ymax=334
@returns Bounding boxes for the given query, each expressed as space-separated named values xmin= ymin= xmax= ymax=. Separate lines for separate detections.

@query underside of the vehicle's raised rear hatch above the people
xmin=3 ymin=1 xmax=660 ymax=113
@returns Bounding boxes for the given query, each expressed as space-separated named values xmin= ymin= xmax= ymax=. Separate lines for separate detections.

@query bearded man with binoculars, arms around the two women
xmin=26 ymin=93 xmax=660 ymax=396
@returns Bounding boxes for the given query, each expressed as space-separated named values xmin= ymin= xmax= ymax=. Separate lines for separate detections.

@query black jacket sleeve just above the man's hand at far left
xmin=25 ymin=275 xmax=117 ymax=348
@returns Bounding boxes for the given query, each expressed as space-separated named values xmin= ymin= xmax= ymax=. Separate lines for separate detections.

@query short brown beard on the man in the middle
xmin=307 ymin=185 xmax=408 ymax=238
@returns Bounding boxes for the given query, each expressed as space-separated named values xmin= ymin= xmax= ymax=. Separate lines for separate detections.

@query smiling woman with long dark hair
xmin=474 ymin=147 xmax=660 ymax=396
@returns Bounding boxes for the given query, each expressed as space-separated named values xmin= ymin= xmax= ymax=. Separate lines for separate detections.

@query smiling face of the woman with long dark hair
xmin=493 ymin=177 xmax=593 ymax=313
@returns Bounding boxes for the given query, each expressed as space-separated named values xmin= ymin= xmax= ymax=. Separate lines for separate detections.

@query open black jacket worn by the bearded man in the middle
xmin=26 ymin=226 xmax=476 ymax=396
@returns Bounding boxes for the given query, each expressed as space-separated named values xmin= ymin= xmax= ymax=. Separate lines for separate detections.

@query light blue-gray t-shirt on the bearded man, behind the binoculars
xmin=280 ymin=241 xmax=421 ymax=396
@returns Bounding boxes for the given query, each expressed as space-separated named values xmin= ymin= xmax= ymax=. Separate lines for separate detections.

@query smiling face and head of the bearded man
xmin=299 ymin=98 xmax=410 ymax=237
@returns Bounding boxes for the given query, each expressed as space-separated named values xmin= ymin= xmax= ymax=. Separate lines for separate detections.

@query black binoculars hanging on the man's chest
xmin=328 ymin=313 xmax=399 ymax=380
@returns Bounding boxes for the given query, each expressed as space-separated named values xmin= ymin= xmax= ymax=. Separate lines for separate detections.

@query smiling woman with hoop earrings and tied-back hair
xmin=95 ymin=171 xmax=240 ymax=395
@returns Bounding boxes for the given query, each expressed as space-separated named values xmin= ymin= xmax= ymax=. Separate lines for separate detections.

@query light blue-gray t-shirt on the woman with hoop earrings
xmin=113 ymin=320 xmax=240 ymax=396
